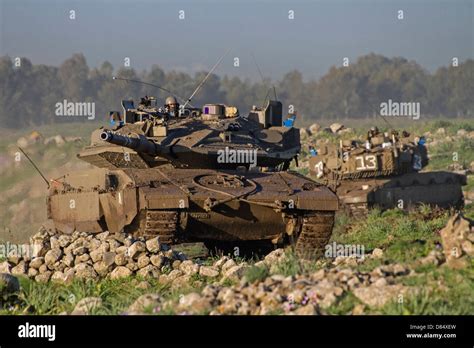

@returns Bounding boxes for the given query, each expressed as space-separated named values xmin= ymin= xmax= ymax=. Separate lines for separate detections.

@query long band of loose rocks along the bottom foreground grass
xmin=125 ymin=259 xmax=415 ymax=315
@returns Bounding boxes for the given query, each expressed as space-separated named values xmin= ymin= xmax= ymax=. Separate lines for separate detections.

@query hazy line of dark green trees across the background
xmin=0 ymin=54 xmax=474 ymax=128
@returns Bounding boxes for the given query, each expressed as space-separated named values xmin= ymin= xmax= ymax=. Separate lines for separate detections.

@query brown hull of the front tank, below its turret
xmin=48 ymin=167 xmax=338 ymax=253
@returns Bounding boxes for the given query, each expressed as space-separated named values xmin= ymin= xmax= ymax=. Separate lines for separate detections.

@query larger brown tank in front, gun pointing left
xmin=48 ymin=97 xmax=338 ymax=256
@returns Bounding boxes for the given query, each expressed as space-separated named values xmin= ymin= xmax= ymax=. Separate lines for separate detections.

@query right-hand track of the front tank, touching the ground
xmin=295 ymin=212 xmax=335 ymax=259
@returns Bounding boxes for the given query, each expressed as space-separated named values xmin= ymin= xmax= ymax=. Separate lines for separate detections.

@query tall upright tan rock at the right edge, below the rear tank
xmin=440 ymin=213 xmax=474 ymax=268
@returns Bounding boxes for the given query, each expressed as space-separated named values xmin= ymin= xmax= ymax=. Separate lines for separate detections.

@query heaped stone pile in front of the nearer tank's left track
xmin=0 ymin=224 xmax=194 ymax=282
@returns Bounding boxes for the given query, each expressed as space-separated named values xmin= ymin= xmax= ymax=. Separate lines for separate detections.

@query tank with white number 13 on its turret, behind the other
xmin=309 ymin=127 xmax=466 ymax=217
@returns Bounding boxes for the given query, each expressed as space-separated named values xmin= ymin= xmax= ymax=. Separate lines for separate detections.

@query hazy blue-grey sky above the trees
xmin=0 ymin=0 xmax=474 ymax=79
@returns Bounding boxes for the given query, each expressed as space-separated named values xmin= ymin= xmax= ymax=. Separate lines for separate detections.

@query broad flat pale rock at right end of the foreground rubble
xmin=353 ymin=284 xmax=413 ymax=307
